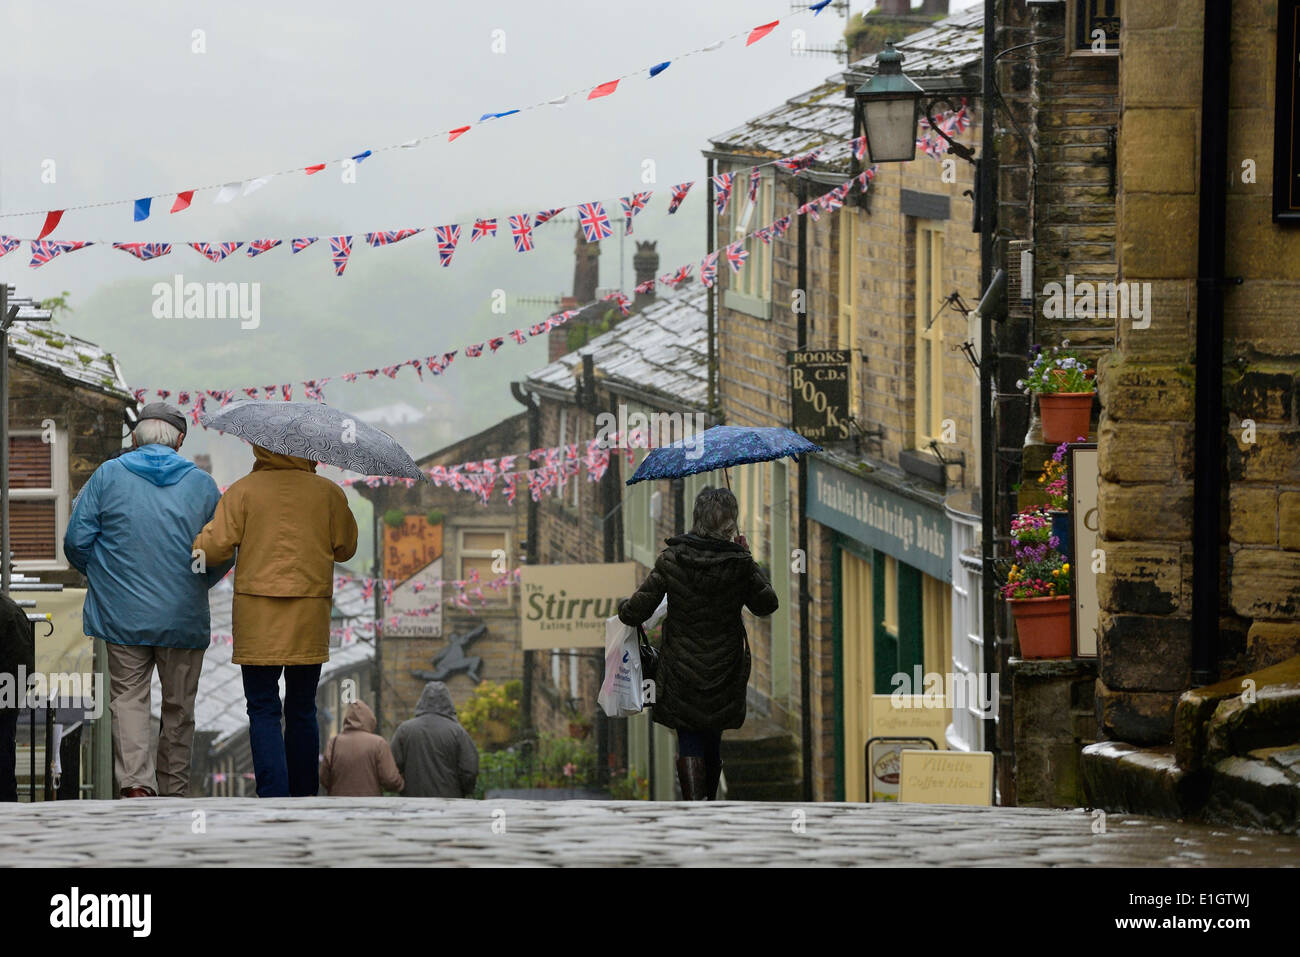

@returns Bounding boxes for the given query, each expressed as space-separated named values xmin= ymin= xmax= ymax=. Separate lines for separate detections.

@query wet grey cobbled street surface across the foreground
xmin=0 ymin=798 xmax=1300 ymax=867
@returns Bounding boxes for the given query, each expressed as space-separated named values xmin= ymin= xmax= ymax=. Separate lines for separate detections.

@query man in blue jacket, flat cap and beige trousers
xmin=64 ymin=402 xmax=233 ymax=797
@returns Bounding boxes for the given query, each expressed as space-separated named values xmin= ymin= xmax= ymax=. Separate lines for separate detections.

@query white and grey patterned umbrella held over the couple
xmin=202 ymin=399 xmax=429 ymax=480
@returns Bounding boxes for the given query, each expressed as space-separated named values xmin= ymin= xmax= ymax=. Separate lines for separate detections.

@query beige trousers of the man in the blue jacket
xmin=105 ymin=641 xmax=205 ymax=797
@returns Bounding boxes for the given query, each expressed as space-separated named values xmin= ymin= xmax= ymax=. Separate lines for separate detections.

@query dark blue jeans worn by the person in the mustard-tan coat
xmin=241 ymin=664 xmax=321 ymax=797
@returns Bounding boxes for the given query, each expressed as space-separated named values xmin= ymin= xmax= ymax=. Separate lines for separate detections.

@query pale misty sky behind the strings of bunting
xmin=0 ymin=0 xmax=969 ymax=496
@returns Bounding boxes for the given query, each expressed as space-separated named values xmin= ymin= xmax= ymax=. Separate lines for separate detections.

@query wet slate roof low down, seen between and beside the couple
xmin=152 ymin=567 xmax=374 ymax=748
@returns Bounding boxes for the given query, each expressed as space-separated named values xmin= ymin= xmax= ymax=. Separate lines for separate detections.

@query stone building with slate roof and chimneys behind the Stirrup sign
xmin=516 ymin=280 xmax=712 ymax=800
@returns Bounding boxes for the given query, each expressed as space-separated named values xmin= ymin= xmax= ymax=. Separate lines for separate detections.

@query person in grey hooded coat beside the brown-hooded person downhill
xmin=391 ymin=681 xmax=478 ymax=797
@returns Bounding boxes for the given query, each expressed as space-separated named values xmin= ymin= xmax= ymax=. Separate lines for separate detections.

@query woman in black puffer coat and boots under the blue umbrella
xmin=619 ymin=486 xmax=779 ymax=801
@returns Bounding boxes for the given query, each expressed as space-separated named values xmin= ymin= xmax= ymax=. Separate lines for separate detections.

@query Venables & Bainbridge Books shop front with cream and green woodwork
xmin=807 ymin=459 xmax=953 ymax=801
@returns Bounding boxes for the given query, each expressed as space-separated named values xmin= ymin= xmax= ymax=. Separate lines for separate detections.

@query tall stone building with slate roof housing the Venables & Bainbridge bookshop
xmin=706 ymin=10 xmax=982 ymax=800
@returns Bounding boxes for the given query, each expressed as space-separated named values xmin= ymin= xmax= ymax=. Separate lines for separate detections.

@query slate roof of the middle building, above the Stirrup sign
xmin=525 ymin=282 xmax=709 ymax=410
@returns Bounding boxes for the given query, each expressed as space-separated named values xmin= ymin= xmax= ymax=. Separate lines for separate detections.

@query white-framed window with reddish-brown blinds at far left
xmin=9 ymin=430 xmax=69 ymax=571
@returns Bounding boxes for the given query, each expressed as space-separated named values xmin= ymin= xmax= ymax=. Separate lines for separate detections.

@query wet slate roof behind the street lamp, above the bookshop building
xmin=711 ymin=5 xmax=984 ymax=172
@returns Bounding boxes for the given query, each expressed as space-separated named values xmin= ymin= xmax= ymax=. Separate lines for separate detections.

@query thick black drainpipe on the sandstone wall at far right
xmin=1192 ymin=0 xmax=1232 ymax=687
